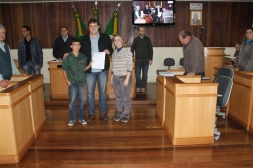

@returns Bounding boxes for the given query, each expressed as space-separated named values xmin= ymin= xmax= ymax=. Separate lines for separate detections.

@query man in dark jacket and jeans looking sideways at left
xmin=18 ymin=26 xmax=43 ymax=74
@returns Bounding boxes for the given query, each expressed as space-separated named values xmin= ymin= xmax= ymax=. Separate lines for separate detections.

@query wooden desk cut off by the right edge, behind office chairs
xmin=228 ymin=71 xmax=253 ymax=130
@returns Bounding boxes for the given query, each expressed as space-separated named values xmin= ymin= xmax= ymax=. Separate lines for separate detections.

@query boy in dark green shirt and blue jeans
xmin=62 ymin=38 xmax=92 ymax=126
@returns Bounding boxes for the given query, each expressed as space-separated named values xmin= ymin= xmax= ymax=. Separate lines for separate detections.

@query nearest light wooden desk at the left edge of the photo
xmin=0 ymin=82 xmax=35 ymax=164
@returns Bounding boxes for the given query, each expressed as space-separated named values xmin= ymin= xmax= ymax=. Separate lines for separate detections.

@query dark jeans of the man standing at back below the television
xmin=135 ymin=58 xmax=149 ymax=88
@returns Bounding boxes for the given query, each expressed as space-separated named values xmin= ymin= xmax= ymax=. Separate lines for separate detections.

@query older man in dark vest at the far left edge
xmin=0 ymin=24 xmax=20 ymax=88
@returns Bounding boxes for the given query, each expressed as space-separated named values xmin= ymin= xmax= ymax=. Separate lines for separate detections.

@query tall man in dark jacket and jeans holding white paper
xmin=80 ymin=18 xmax=113 ymax=121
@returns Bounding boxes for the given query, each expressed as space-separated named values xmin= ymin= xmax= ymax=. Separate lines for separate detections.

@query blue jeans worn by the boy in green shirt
xmin=68 ymin=83 xmax=85 ymax=121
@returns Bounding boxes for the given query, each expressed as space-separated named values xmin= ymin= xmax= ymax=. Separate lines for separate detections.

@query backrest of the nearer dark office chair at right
xmin=214 ymin=76 xmax=233 ymax=107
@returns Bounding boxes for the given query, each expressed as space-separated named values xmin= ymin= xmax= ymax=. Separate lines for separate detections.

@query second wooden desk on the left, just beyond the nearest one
xmin=11 ymin=75 xmax=47 ymax=137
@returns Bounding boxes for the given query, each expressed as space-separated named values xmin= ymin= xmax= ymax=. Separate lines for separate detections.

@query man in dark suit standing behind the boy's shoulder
xmin=53 ymin=26 xmax=74 ymax=60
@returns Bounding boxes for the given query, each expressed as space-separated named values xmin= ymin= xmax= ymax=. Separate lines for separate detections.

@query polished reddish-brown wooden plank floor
xmin=0 ymin=84 xmax=253 ymax=168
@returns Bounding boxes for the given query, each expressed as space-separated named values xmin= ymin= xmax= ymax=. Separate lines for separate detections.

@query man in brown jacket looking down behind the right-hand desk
xmin=178 ymin=30 xmax=205 ymax=77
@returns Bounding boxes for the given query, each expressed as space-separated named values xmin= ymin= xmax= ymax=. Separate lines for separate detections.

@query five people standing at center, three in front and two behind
xmin=56 ymin=18 xmax=153 ymax=126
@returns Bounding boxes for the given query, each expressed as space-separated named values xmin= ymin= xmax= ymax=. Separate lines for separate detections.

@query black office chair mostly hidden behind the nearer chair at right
xmin=214 ymin=67 xmax=234 ymax=118
